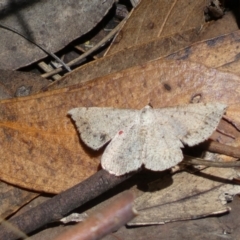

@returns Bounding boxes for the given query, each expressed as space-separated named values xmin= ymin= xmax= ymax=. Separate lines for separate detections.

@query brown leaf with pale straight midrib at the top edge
xmin=108 ymin=0 xmax=238 ymax=54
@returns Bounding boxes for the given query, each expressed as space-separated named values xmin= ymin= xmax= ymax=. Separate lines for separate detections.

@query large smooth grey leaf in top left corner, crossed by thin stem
xmin=0 ymin=0 xmax=114 ymax=69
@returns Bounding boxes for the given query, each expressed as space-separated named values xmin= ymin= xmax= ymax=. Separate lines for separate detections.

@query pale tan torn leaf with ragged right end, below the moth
xmin=128 ymin=168 xmax=240 ymax=226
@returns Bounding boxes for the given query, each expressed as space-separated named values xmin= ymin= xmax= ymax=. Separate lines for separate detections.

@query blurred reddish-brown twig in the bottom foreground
xmin=54 ymin=191 xmax=137 ymax=240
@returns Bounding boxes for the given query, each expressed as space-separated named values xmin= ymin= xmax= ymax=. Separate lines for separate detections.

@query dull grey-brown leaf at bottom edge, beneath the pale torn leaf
xmin=103 ymin=211 xmax=236 ymax=240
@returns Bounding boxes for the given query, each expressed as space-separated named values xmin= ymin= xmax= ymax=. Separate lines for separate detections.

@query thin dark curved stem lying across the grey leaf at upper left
xmin=0 ymin=23 xmax=71 ymax=72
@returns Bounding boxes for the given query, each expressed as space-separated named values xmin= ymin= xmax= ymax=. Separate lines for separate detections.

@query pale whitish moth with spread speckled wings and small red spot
xmin=68 ymin=103 xmax=226 ymax=176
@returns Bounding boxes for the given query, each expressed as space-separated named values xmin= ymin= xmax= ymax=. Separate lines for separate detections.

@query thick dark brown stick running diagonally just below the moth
xmin=0 ymin=170 xmax=133 ymax=240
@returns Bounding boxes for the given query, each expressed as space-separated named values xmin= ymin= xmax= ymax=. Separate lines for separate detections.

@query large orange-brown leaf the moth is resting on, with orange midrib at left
xmin=0 ymin=60 xmax=240 ymax=193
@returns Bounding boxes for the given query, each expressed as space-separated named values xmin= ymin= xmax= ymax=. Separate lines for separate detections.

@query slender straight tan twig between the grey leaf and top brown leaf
xmin=41 ymin=17 xmax=127 ymax=78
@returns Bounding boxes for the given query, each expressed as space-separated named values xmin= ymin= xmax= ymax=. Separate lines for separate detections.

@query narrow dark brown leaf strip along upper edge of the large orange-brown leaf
xmin=46 ymin=28 xmax=200 ymax=90
